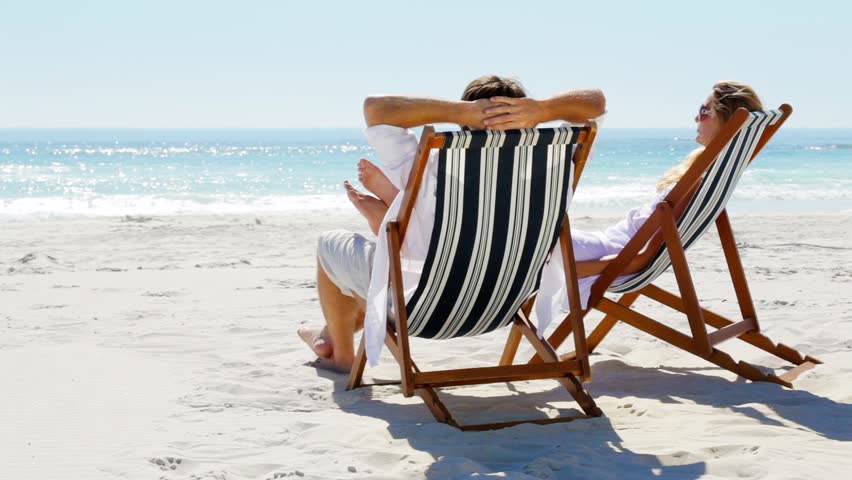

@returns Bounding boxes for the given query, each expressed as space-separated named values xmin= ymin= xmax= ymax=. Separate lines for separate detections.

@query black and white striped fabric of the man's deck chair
xmin=406 ymin=127 xmax=581 ymax=339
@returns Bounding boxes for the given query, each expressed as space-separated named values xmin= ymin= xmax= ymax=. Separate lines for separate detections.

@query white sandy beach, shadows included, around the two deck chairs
xmin=0 ymin=209 xmax=852 ymax=480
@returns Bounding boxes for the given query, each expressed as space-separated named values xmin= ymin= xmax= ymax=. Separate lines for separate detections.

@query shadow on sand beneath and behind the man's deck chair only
xmin=320 ymin=366 xmax=706 ymax=479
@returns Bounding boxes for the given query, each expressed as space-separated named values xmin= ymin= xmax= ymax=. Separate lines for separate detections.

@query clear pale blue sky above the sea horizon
xmin=0 ymin=0 xmax=852 ymax=128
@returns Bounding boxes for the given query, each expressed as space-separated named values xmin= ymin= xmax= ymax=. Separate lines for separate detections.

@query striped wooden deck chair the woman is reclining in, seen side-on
xmin=507 ymin=104 xmax=821 ymax=388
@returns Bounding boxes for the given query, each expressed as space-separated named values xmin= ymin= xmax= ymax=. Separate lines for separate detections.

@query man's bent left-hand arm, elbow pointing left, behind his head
xmin=364 ymin=95 xmax=491 ymax=129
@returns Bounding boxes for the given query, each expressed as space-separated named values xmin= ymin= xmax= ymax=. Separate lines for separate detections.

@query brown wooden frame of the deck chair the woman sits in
xmin=503 ymin=104 xmax=822 ymax=388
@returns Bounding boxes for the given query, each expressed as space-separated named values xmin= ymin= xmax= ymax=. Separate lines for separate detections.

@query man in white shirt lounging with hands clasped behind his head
xmin=299 ymin=76 xmax=605 ymax=372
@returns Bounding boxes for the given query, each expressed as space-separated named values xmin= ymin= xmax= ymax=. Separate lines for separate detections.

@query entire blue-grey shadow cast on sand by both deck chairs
xmin=320 ymin=354 xmax=852 ymax=479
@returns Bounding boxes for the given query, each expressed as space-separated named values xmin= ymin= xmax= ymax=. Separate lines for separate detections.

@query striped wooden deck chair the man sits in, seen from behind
xmin=348 ymin=123 xmax=601 ymax=430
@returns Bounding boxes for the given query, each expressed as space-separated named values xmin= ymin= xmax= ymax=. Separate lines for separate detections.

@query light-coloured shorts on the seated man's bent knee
xmin=317 ymin=230 xmax=376 ymax=299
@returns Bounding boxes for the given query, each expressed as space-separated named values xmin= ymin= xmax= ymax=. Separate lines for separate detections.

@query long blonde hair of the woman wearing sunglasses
xmin=657 ymin=80 xmax=763 ymax=191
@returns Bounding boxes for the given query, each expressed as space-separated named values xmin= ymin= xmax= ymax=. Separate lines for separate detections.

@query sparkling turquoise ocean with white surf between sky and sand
xmin=0 ymin=128 xmax=852 ymax=220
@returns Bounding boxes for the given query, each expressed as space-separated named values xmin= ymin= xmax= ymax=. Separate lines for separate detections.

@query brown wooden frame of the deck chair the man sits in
xmin=347 ymin=122 xmax=602 ymax=430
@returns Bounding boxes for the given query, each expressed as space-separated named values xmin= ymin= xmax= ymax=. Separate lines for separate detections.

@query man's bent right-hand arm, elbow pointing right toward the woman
xmin=483 ymin=88 xmax=606 ymax=130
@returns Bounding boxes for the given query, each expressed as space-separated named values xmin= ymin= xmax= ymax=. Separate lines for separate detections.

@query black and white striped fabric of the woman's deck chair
xmin=609 ymin=110 xmax=783 ymax=293
